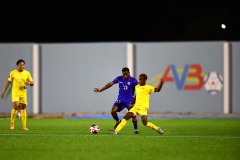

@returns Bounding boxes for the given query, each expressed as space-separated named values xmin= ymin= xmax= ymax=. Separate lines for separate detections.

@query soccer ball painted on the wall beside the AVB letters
xmin=204 ymin=72 xmax=223 ymax=95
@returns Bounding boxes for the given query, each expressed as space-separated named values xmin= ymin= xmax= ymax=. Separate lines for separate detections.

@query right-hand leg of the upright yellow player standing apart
xmin=20 ymin=97 xmax=29 ymax=130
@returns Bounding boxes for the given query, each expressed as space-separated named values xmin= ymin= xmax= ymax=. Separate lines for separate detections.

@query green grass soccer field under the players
xmin=0 ymin=118 xmax=240 ymax=160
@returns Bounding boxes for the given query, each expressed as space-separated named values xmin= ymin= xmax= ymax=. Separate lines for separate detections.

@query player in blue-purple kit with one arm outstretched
xmin=94 ymin=67 xmax=139 ymax=134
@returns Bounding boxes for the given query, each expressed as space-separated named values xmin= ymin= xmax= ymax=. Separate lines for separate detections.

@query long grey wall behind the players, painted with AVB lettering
xmin=0 ymin=42 xmax=240 ymax=114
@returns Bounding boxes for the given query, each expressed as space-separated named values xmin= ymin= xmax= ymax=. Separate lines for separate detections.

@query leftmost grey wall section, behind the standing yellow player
xmin=0 ymin=43 xmax=33 ymax=113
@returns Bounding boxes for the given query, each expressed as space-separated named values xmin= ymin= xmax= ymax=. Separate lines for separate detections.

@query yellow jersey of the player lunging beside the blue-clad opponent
xmin=134 ymin=84 xmax=155 ymax=109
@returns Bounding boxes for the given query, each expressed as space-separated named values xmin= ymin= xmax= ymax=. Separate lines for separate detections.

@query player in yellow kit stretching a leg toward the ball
xmin=107 ymin=73 xmax=164 ymax=134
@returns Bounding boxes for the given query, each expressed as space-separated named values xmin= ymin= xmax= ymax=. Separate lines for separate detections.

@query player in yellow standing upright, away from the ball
xmin=1 ymin=59 xmax=34 ymax=130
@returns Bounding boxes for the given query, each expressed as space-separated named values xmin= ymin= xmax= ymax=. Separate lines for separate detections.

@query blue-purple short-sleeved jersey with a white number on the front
xmin=113 ymin=76 xmax=138 ymax=102
